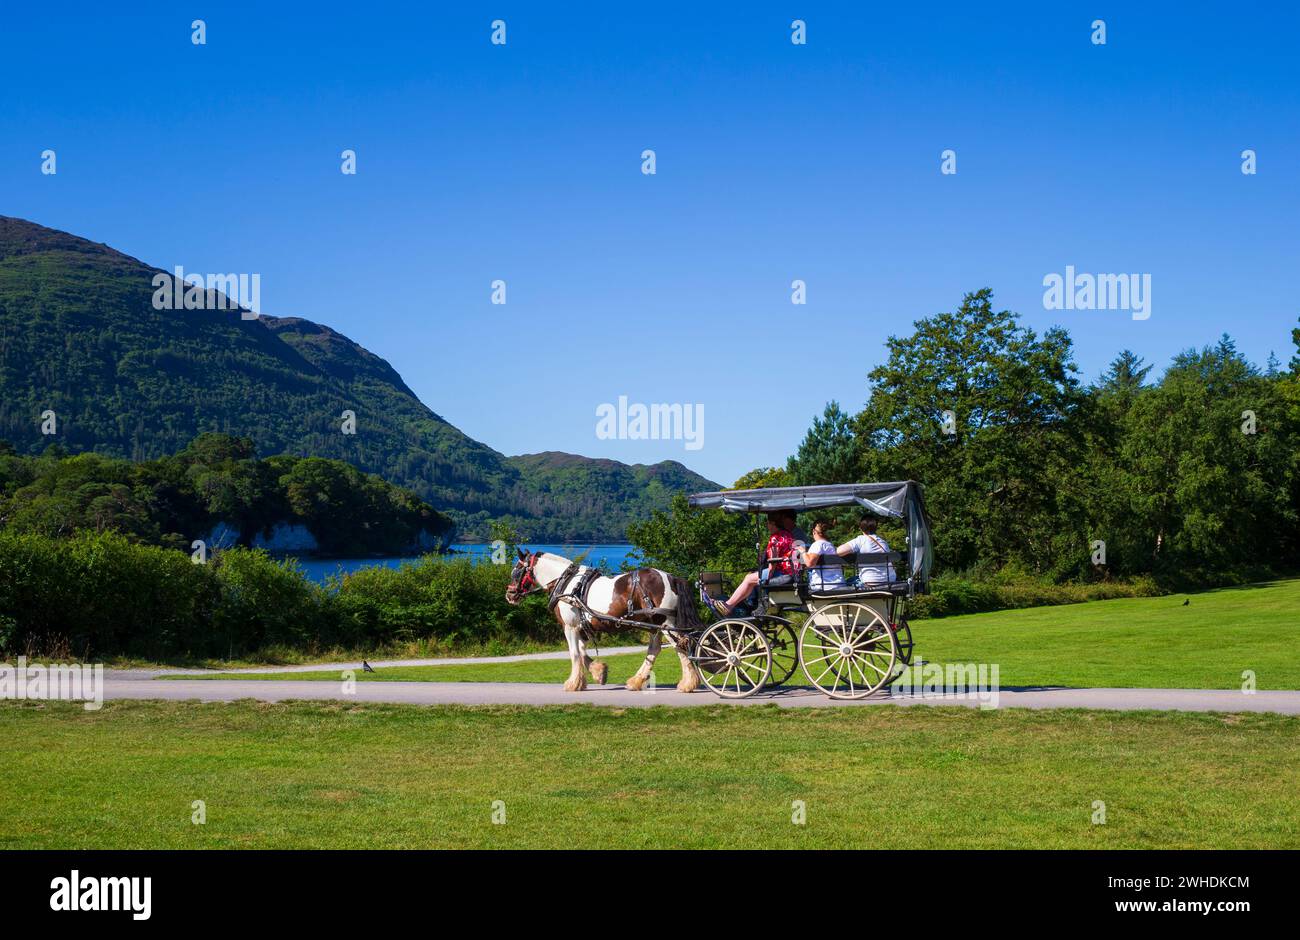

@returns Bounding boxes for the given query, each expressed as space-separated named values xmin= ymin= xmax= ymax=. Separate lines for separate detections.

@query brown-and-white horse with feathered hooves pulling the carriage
xmin=506 ymin=550 xmax=703 ymax=692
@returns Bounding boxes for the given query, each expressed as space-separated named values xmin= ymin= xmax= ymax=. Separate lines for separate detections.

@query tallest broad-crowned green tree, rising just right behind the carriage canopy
xmin=854 ymin=289 xmax=1089 ymax=575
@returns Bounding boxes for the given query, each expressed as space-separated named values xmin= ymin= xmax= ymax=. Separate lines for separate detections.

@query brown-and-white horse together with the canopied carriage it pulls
xmin=506 ymin=481 xmax=932 ymax=698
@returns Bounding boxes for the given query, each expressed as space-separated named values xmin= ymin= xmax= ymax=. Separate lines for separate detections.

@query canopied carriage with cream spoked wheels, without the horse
xmin=689 ymin=481 xmax=932 ymax=698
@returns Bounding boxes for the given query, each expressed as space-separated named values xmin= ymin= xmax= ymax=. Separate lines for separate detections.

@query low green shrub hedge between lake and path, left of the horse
xmin=0 ymin=533 xmax=559 ymax=659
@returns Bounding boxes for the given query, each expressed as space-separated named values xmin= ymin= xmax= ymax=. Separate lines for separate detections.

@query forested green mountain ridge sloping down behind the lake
xmin=0 ymin=216 xmax=716 ymax=541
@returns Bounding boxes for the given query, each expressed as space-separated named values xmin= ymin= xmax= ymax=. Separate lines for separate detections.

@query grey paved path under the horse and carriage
xmin=96 ymin=676 xmax=1300 ymax=715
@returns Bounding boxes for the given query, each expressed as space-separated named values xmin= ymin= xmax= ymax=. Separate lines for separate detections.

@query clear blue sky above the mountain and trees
xmin=0 ymin=0 xmax=1300 ymax=482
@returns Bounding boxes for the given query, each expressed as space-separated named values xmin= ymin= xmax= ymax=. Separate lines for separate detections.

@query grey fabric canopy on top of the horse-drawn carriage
xmin=686 ymin=480 xmax=933 ymax=585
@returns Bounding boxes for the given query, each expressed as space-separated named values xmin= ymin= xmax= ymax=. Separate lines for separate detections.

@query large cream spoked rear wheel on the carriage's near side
xmin=800 ymin=602 xmax=898 ymax=698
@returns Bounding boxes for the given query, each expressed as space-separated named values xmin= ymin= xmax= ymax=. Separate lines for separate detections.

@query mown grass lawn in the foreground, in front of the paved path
xmin=0 ymin=701 xmax=1300 ymax=849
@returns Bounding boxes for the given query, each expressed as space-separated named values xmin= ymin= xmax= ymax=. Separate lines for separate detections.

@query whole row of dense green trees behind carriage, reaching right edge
xmin=632 ymin=290 xmax=1300 ymax=586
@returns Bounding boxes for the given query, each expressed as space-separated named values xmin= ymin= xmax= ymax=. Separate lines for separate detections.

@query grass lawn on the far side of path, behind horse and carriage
xmin=186 ymin=580 xmax=1300 ymax=689
